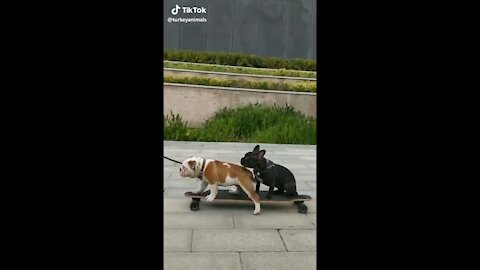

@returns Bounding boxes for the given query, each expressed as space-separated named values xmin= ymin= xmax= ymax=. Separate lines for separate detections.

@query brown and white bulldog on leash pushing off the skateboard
xmin=180 ymin=157 xmax=260 ymax=215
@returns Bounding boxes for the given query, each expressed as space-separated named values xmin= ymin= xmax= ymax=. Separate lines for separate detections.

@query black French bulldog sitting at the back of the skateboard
xmin=240 ymin=145 xmax=298 ymax=199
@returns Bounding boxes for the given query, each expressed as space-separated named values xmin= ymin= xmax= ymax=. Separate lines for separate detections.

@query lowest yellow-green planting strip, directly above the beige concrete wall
xmin=163 ymin=76 xmax=317 ymax=93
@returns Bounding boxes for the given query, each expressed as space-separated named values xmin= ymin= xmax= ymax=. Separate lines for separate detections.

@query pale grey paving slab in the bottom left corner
xmin=163 ymin=252 xmax=242 ymax=270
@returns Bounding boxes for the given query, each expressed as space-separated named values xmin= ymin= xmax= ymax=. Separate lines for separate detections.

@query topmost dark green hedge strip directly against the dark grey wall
xmin=163 ymin=50 xmax=317 ymax=71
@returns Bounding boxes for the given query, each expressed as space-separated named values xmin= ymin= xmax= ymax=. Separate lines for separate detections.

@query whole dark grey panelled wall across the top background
xmin=163 ymin=0 xmax=317 ymax=59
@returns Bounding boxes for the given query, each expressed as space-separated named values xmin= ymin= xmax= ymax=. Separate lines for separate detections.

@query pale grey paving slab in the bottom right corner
xmin=240 ymin=252 xmax=317 ymax=270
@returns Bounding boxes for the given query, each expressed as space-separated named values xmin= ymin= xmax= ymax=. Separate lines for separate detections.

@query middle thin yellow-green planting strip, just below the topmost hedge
xmin=163 ymin=62 xmax=317 ymax=78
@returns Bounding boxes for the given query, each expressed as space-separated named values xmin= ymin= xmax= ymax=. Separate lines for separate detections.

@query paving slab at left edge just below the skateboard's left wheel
xmin=163 ymin=213 xmax=234 ymax=229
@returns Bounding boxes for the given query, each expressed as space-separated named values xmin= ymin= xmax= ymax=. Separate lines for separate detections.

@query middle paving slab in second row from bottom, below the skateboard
xmin=192 ymin=230 xmax=286 ymax=251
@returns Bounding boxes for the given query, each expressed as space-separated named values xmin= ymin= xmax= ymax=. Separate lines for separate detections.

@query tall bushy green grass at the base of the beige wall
xmin=163 ymin=104 xmax=317 ymax=145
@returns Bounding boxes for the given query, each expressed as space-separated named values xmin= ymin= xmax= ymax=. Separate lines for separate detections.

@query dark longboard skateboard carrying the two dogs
xmin=185 ymin=190 xmax=312 ymax=214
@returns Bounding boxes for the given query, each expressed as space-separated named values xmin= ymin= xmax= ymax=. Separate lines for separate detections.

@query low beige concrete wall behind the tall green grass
xmin=163 ymin=83 xmax=317 ymax=127
